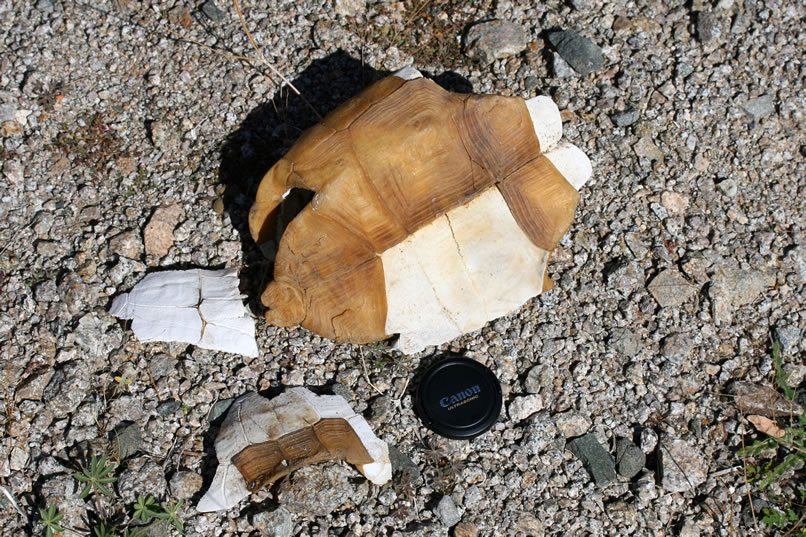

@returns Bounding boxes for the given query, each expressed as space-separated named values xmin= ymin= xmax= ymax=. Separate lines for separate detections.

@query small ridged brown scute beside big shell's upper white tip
xmin=461 ymin=95 xmax=540 ymax=175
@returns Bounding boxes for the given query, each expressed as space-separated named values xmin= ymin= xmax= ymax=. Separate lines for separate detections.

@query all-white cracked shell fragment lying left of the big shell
xmin=109 ymin=268 xmax=258 ymax=356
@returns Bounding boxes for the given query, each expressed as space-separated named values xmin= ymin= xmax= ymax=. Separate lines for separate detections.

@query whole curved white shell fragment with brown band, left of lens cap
xmin=196 ymin=388 xmax=392 ymax=513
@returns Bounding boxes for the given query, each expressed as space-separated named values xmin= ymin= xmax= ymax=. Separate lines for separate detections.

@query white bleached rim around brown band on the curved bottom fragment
xmin=196 ymin=388 xmax=392 ymax=512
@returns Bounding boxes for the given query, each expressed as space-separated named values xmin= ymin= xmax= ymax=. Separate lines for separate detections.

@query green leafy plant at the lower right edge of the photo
xmin=739 ymin=341 xmax=806 ymax=537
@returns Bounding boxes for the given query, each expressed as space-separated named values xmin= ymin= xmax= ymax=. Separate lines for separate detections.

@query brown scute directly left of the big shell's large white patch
xmin=302 ymin=257 xmax=389 ymax=343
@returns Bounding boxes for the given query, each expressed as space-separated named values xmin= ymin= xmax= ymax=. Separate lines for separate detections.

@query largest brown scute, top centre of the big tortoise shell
xmin=349 ymin=78 xmax=477 ymax=233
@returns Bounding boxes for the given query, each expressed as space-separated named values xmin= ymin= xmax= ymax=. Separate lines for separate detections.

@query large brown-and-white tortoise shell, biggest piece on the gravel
xmin=249 ymin=68 xmax=591 ymax=352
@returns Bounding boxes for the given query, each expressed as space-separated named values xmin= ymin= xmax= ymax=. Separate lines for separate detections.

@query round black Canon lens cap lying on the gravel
xmin=416 ymin=354 xmax=503 ymax=440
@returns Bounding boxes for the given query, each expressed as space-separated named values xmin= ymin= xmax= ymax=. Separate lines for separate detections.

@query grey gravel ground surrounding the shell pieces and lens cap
xmin=0 ymin=0 xmax=806 ymax=537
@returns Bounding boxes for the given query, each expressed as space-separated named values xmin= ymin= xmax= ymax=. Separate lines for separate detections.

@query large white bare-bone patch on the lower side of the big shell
xmin=381 ymin=187 xmax=548 ymax=354
